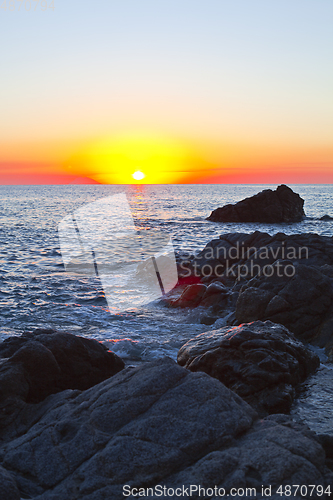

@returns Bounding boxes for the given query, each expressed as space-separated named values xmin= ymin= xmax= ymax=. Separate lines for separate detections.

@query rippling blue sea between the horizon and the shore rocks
xmin=0 ymin=184 xmax=333 ymax=435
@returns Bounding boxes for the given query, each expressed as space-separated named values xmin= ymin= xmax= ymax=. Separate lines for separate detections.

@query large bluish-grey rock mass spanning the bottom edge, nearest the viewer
xmin=0 ymin=359 xmax=333 ymax=500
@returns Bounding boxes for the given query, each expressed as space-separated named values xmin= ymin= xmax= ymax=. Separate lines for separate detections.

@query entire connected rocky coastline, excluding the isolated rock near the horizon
xmin=0 ymin=188 xmax=333 ymax=500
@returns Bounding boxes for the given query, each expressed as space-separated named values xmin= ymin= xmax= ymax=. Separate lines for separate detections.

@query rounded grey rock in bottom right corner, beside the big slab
xmin=170 ymin=415 xmax=332 ymax=500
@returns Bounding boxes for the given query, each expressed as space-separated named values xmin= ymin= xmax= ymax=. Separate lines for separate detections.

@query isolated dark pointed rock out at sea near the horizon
xmin=207 ymin=184 xmax=305 ymax=223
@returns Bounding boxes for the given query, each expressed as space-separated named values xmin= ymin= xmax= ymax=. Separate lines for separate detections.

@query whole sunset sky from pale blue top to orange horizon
xmin=0 ymin=0 xmax=333 ymax=184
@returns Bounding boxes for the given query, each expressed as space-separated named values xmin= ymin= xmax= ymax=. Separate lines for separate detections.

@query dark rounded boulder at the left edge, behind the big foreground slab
xmin=0 ymin=330 xmax=124 ymax=425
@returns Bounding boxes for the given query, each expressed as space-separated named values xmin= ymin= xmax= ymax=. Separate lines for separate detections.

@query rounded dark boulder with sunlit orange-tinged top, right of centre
xmin=177 ymin=321 xmax=320 ymax=415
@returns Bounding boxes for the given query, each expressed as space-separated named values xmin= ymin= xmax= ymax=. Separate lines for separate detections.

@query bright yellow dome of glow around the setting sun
xmin=66 ymin=134 xmax=209 ymax=184
